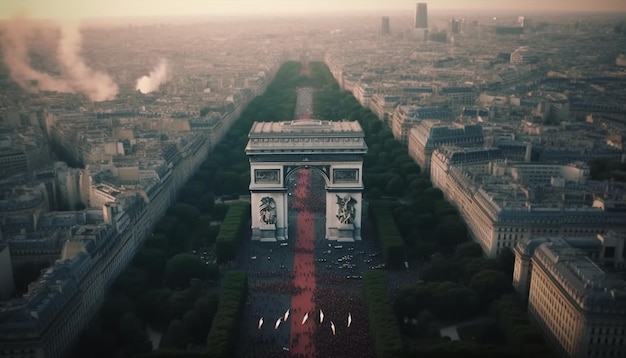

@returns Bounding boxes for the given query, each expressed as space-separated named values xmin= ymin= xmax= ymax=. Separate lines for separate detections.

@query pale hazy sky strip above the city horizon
xmin=0 ymin=0 xmax=626 ymax=19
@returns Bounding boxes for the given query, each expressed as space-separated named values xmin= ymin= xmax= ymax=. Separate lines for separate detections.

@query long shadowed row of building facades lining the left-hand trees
xmin=0 ymin=132 xmax=210 ymax=358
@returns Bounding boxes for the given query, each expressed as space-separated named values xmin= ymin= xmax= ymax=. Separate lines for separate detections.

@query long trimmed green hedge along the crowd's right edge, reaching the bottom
xmin=363 ymin=271 xmax=403 ymax=358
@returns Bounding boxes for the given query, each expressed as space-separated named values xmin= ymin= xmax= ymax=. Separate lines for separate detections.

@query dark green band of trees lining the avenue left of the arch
xmin=74 ymin=62 xmax=310 ymax=357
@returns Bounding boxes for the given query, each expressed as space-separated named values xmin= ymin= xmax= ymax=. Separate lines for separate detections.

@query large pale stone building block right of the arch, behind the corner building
xmin=430 ymin=147 xmax=626 ymax=257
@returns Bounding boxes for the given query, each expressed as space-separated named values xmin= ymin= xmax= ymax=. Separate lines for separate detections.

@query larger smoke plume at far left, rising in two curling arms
xmin=0 ymin=18 xmax=118 ymax=101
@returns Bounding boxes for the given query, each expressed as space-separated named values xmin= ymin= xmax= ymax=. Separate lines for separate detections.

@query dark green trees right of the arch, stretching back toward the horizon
xmin=310 ymin=62 xmax=467 ymax=258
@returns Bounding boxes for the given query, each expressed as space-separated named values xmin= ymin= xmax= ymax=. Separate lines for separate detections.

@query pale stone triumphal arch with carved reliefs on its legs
xmin=246 ymin=119 xmax=367 ymax=241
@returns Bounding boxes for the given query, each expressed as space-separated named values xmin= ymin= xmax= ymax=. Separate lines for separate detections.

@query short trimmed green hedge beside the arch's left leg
xmin=215 ymin=201 xmax=250 ymax=263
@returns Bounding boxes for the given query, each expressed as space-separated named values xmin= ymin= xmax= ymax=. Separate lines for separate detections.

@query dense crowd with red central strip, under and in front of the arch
xmin=237 ymin=170 xmax=374 ymax=358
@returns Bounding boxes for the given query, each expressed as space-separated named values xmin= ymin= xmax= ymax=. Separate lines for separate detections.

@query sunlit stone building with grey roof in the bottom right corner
xmin=513 ymin=233 xmax=626 ymax=358
